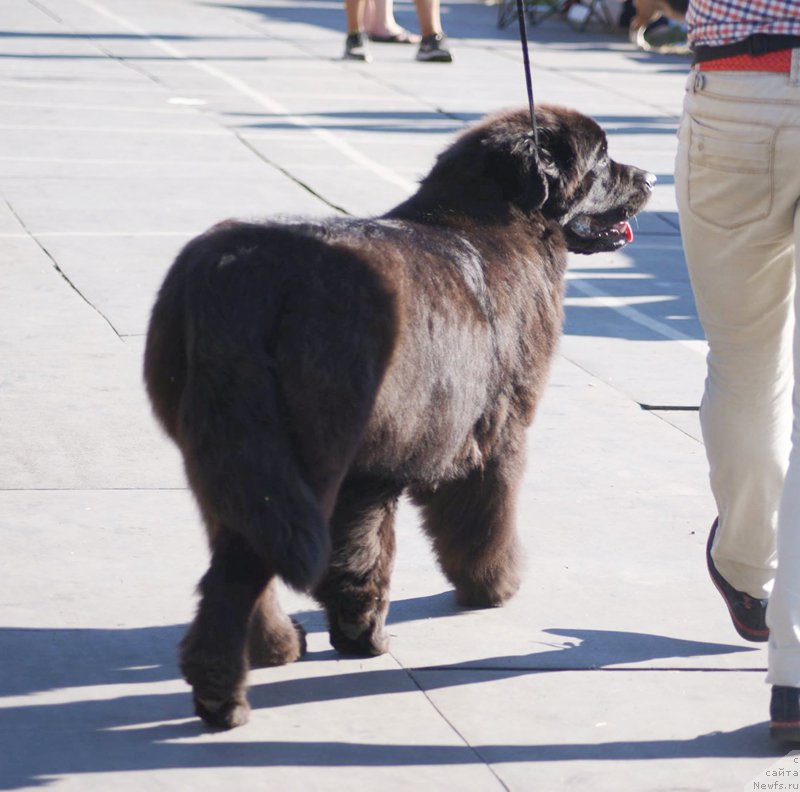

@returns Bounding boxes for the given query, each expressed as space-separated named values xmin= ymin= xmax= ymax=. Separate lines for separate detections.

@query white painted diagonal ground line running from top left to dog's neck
xmin=75 ymin=0 xmax=416 ymax=193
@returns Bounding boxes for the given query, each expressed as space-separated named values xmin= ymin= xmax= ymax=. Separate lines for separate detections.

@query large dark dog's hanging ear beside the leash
xmin=484 ymin=133 xmax=550 ymax=212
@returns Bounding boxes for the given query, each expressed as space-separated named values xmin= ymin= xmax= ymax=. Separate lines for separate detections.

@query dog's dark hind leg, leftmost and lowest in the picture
xmin=180 ymin=528 xmax=272 ymax=729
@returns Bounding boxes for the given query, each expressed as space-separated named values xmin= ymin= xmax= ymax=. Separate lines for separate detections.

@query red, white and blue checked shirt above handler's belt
xmin=686 ymin=0 xmax=800 ymax=47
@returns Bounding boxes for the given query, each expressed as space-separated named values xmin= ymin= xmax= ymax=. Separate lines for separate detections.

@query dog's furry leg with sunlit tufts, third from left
xmin=314 ymin=480 xmax=400 ymax=656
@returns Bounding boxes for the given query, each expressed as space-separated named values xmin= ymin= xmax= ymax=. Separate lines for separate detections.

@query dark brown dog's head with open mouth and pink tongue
xmin=412 ymin=106 xmax=656 ymax=253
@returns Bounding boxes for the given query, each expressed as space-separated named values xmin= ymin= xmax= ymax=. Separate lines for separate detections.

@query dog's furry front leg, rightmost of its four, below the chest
xmin=413 ymin=438 xmax=524 ymax=607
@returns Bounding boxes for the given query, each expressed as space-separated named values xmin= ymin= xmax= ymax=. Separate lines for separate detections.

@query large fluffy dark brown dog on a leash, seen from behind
xmin=145 ymin=107 xmax=655 ymax=727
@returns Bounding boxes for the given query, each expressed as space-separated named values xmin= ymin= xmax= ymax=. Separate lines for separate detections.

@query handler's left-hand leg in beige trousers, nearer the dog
xmin=676 ymin=75 xmax=796 ymax=598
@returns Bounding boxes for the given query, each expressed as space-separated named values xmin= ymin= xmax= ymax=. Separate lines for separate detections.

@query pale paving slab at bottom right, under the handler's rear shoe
xmin=414 ymin=671 xmax=776 ymax=792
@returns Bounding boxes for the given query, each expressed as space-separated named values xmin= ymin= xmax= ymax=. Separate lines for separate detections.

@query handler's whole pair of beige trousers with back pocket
xmin=675 ymin=57 xmax=800 ymax=687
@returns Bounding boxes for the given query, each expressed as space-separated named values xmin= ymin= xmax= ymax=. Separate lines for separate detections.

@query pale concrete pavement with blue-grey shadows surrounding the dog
xmin=0 ymin=0 xmax=785 ymax=792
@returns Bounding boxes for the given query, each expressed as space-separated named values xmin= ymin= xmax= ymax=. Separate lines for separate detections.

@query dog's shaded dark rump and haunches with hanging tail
xmin=144 ymin=223 xmax=391 ymax=589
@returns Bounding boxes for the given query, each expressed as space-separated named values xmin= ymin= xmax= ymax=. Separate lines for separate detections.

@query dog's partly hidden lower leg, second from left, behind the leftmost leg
xmin=248 ymin=579 xmax=306 ymax=666
